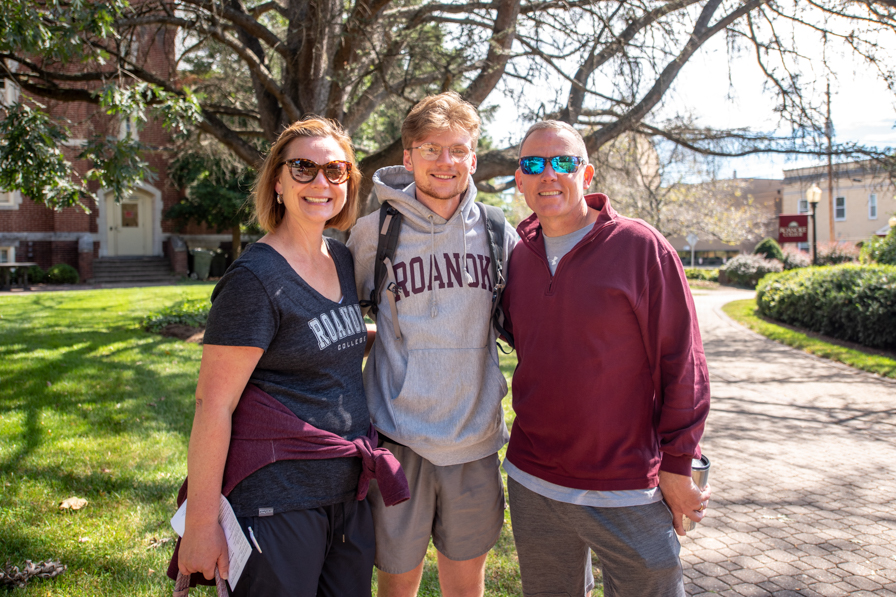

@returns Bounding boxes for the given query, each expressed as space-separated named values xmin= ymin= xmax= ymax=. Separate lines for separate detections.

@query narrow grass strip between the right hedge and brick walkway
xmin=722 ymin=299 xmax=896 ymax=379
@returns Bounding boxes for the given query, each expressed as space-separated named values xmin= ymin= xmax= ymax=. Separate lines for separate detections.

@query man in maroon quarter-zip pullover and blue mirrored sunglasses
xmin=504 ymin=121 xmax=710 ymax=597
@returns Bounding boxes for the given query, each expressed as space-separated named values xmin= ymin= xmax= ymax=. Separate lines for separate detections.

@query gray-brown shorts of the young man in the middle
xmin=367 ymin=442 xmax=504 ymax=574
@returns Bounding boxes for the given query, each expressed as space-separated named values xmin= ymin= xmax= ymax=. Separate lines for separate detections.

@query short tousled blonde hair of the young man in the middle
xmin=401 ymin=91 xmax=482 ymax=151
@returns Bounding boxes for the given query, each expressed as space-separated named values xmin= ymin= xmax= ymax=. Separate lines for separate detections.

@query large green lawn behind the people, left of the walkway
xmin=0 ymin=284 xmax=601 ymax=597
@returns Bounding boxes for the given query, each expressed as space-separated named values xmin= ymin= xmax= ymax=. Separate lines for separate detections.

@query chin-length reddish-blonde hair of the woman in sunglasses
xmin=252 ymin=116 xmax=361 ymax=232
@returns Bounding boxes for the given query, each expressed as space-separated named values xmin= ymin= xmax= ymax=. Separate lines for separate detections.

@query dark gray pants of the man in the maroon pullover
xmin=507 ymin=478 xmax=685 ymax=597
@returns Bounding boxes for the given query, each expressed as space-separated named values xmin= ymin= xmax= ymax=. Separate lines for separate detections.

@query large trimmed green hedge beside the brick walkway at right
xmin=756 ymin=264 xmax=896 ymax=349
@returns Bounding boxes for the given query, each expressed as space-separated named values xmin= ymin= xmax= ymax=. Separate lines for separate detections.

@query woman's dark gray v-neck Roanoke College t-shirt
xmin=204 ymin=239 xmax=370 ymax=516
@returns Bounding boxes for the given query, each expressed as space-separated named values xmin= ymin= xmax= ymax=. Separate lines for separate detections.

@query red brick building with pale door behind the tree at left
xmin=0 ymin=28 xmax=224 ymax=281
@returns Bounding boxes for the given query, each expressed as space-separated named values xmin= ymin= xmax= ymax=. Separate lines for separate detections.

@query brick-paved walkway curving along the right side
xmin=682 ymin=290 xmax=896 ymax=597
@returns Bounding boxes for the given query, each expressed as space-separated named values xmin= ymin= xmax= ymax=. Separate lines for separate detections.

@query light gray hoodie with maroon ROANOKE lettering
xmin=348 ymin=166 xmax=519 ymax=466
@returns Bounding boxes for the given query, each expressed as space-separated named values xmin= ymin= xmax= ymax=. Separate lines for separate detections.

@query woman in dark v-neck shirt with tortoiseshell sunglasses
xmin=178 ymin=118 xmax=382 ymax=597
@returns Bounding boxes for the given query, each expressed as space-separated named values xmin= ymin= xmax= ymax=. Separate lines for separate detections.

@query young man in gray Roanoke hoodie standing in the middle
xmin=348 ymin=92 xmax=518 ymax=597
